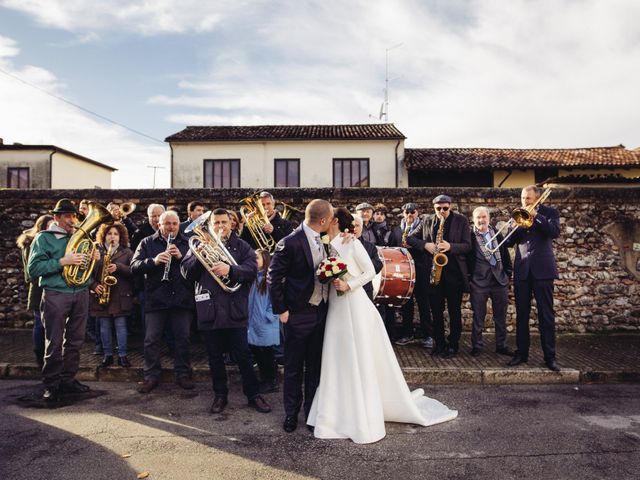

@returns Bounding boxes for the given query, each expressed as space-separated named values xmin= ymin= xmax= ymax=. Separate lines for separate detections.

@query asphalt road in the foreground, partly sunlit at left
xmin=0 ymin=380 xmax=640 ymax=480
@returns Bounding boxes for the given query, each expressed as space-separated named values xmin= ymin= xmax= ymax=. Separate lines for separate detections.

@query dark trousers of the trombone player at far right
xmin=513 ymin=276 xmax=556 ymax=361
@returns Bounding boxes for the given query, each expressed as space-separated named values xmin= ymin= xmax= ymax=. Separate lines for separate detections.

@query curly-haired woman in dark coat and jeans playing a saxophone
xmin=89 ymin=224 xmax=133 ymax=368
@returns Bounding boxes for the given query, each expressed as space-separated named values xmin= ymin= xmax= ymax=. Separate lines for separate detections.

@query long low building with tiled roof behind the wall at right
xmin=403 ymin=145 xmax=640 ymax=188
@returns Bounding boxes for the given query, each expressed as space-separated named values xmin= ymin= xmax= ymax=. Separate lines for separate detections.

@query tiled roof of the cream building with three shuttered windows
xmin=165 ymin=123 xmax=406 ymax=142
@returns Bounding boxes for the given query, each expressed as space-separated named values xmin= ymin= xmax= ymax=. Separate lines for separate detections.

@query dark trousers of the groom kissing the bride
xmin=283 ymin=302 xmax=327 ymax=418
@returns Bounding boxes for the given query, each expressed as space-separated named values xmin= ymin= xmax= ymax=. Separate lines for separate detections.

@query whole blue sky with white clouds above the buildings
xmin=0 ymin=0 xmax=640 ymax=188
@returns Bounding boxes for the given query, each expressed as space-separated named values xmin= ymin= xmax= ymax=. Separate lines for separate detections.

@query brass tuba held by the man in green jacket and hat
xmin=62 ymin=202 xmax=113 ymax=287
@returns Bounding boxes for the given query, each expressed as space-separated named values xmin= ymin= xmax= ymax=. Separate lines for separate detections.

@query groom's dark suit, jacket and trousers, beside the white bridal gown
xmin=267 ymin=225 xmax=327 ymax=417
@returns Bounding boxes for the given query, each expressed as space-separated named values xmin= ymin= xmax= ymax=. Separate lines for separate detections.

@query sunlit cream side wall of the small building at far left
xmin=51 ymin=152 xmax=111 ymax=189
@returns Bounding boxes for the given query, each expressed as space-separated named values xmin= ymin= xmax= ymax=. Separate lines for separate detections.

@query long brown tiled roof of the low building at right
xmin=404 ymin=145 xmax=640 ymax=170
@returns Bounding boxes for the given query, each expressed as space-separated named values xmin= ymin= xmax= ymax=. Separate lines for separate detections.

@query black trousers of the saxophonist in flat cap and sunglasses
xmin=429 ymin=282 xmax=463 ymax=351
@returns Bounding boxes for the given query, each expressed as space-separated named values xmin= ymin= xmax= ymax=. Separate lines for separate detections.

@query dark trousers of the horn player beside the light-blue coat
xmin=202 ymin=328 xmax=259 ymax=400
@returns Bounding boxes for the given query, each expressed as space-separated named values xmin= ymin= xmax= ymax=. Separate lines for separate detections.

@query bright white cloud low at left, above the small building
xmin=0 ymin=37 xmax=169 ymax=188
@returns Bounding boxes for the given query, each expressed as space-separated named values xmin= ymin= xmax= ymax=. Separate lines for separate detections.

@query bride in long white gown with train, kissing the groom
xmin=307 ymin=208 xmax=458 ymax=443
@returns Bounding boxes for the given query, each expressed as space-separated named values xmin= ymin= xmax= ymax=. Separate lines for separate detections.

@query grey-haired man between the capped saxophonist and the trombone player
xmin=467 ymin=207 xmax=513 ymax=357
